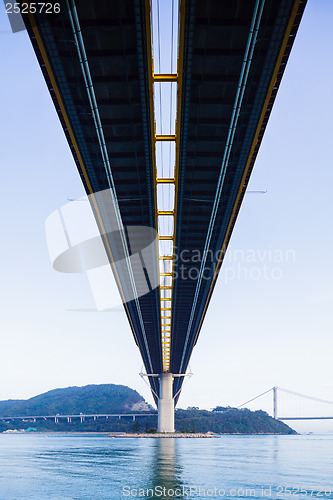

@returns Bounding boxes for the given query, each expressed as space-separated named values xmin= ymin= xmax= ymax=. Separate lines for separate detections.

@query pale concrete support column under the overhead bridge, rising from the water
xmin=157 ymin=373 xmax=175 ymax=432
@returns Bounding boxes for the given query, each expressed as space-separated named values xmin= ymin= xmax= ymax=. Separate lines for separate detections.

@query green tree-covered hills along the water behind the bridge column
xmin=0 ymin=384 xmax=296 ymax=434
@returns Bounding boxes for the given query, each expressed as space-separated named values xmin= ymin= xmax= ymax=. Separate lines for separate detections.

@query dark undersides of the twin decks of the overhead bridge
xmin=24 ymin=0 xmax=306 ymax=399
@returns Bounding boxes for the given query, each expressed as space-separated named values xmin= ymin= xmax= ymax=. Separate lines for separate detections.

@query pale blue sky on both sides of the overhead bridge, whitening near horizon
xmin=0 ymin=0 xmax=333 ymax=434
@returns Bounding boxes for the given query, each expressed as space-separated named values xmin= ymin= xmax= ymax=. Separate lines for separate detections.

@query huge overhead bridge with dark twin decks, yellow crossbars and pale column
xmin=15 ymin=0 xmax=306 ymax=432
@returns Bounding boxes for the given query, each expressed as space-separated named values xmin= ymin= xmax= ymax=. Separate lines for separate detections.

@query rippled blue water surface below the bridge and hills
xmin=0 ymin=434 xmax=333 ymax=500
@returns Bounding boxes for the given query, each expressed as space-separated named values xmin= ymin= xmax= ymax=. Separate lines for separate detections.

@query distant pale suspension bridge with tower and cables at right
xmin=238 ymin=386 xmax=333 ymax=420
